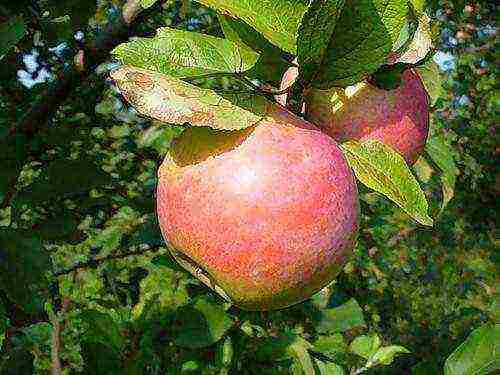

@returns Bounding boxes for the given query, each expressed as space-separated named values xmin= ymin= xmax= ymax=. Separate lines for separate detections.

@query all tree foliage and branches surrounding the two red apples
xmin=0 ymin=0 xmax=494 ymax=375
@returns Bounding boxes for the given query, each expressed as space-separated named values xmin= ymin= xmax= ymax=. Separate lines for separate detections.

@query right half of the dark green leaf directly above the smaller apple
xmin=312 ymin=0 xmax=408 ymax=89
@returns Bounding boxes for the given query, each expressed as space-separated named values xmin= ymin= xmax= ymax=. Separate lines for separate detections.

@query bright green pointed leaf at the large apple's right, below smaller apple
xmin=341 ymin=140 xmax=433 ymax=226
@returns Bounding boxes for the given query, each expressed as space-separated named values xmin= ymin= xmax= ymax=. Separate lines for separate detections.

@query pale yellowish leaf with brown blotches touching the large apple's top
xmin=111 ymin=66 xmax=267 ymax=130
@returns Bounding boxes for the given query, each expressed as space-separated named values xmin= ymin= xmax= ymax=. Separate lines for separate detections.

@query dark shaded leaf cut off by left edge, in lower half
xmin=0 ymin=230 xmax=51 ymax=314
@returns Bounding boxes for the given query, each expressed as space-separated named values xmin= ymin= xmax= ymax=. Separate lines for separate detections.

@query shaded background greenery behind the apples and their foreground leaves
xmin=0 ymin=0 xmax=500 ymax=374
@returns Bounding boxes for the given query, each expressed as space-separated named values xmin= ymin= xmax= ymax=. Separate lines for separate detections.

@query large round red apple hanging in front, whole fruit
xmin=157 ymin=105 xmax=359 ymax=310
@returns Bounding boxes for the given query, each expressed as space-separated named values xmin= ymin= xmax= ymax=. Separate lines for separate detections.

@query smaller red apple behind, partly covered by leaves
xmin=276 ymin=67 xmax=429 ymax=165
